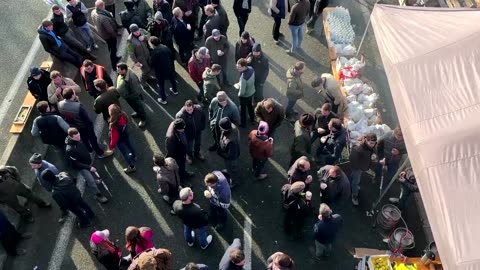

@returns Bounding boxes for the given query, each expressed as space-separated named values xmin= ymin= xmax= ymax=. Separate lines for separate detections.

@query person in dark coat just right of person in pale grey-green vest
xmin=247 ymin=43 xmax=270 ymax=104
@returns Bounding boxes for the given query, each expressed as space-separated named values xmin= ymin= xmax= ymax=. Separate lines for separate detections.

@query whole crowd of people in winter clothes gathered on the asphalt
xmin=0 ymin=0 xmax=416 ymax=270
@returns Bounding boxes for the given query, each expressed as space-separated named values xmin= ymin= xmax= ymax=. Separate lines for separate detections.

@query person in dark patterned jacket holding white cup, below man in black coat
xmin=153 ymin=154 xmax=181 ymax=205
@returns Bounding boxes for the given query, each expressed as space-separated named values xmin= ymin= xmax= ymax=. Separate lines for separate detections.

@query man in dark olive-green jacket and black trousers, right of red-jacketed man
xmin=117 ymin=63 xmax=147 ymax=128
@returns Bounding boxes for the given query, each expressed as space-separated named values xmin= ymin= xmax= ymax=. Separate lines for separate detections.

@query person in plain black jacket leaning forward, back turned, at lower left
xmin=41 ymin=169 xmax=95 ymax=228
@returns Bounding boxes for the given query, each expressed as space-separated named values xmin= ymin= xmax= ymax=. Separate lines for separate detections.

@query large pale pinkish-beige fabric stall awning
xmin=371 ymin=5 xmax=480 ymax=270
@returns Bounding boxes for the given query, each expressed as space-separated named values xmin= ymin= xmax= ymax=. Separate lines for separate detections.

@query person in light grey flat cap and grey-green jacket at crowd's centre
xmin=208 ymin=91 xmax=240 ymax=151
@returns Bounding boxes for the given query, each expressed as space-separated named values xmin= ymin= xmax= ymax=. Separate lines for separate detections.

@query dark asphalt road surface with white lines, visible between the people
xmin=0 ymin=1 xmax=421 ymax=270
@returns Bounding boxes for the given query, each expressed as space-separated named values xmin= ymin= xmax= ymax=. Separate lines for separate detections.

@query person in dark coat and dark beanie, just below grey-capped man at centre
xmin=217 ymin=117 xmax=240 ymax=188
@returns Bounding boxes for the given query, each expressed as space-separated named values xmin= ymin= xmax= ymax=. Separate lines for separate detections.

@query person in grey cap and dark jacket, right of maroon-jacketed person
xmin=205 ymin=29 xmax=230 ymax=85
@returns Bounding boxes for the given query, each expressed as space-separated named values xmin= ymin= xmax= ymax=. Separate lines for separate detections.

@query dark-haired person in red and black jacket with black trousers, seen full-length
xmin=108 ymin=104 xmax=137 ymax=173
